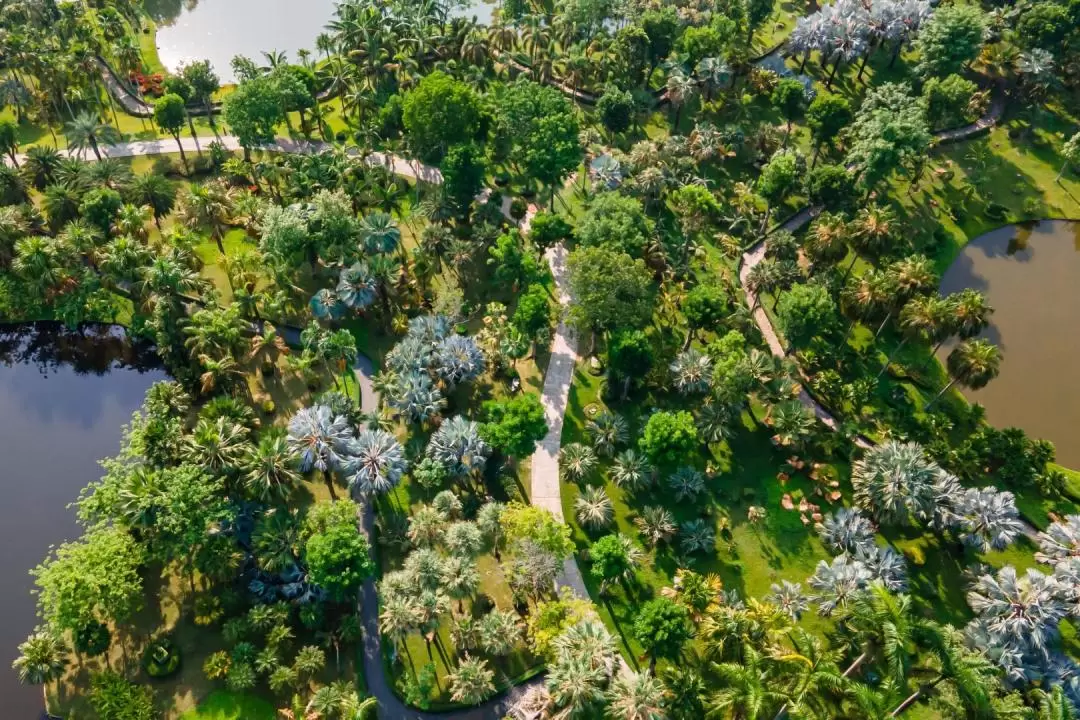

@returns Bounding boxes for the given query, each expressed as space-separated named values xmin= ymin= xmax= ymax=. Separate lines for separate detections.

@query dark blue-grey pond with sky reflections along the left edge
xmin=0 ymin=323 xmax=166 ymax=720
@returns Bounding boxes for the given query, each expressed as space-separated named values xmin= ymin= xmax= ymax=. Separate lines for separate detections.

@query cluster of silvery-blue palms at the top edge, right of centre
xmin=787 ymin=0 xmax=933 ymax=87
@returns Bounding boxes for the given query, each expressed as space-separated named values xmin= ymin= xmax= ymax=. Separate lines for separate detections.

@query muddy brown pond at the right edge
xmin=942 ymin=220 xmax=1080 ymax=468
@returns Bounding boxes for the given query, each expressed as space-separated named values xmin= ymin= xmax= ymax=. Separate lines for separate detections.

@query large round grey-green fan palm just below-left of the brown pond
xmin=851 ymin=440 xmax=945 ymax=525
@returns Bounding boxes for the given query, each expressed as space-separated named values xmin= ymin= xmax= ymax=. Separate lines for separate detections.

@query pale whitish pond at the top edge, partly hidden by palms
xmin=143 ymin=0 xmax=495 ymax=83
